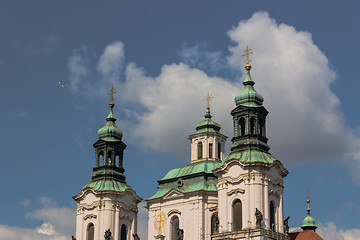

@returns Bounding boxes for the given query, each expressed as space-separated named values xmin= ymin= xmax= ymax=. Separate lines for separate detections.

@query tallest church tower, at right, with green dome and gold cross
xmin=212 ymin=48 xmax=288 ymax=239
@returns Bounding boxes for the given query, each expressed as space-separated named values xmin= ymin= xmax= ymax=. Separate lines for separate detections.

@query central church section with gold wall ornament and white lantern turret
xmin=146 ymin=94 xmax=227 ymax=240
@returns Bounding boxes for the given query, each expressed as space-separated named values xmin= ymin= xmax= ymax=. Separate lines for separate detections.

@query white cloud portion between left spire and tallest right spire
xmin=120 ymin=63 xmax=239 ymax=156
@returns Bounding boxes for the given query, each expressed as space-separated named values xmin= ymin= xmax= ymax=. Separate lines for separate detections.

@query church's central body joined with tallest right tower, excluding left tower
xmin=146 ymin=49 xmax=288 ymax=240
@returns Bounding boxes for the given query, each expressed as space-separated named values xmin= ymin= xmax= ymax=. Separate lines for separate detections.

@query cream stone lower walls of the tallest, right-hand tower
xmin=215 ymin=160 xmax=286 ymax=233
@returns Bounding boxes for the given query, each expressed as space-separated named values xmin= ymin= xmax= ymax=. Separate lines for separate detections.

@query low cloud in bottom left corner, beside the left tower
xmin=0 ymin=197 xmax=75 ymax=240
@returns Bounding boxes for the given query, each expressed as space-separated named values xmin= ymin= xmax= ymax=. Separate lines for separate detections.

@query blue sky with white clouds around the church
xmin=0 ymin=0 xmax=360 ymax=240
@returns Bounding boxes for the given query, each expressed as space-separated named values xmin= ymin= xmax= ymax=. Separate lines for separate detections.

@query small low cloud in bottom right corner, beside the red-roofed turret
xmin=316 ymin=222 xmax=360 ymax=240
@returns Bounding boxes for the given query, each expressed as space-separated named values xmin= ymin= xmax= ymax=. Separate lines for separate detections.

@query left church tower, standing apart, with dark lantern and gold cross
xmin=73 ymin=87 xmax=142 ymax=240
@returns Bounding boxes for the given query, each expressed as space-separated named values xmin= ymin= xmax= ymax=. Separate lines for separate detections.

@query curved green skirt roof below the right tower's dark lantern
xmin=221 ymin=150 xmax=277 ymax=165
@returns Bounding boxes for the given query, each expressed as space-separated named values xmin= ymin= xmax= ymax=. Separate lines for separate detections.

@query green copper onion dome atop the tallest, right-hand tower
xmin=235 ymin=71 xmax=264 ymax=107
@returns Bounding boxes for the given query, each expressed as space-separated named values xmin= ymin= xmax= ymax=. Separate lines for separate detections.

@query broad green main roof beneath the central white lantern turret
xmin=148 ymin=161 xmax=220 ymax=200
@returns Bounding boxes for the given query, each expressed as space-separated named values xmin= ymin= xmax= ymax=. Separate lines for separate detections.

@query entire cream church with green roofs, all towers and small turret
xmin=73 ymin=48 xmax=322 ymax=240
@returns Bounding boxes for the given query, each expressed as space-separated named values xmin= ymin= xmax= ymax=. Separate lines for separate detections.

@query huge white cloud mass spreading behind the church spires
xmin=69 ymin=12 xmax=360 ymax=181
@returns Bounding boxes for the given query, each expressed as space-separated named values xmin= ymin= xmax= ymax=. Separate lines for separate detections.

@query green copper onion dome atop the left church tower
xmin=98 ymin=108 xmax=123 ymax=142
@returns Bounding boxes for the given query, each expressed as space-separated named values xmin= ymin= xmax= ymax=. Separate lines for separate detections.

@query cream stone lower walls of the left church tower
xmin=74 ymin=189 xmax=141 ymax=240
